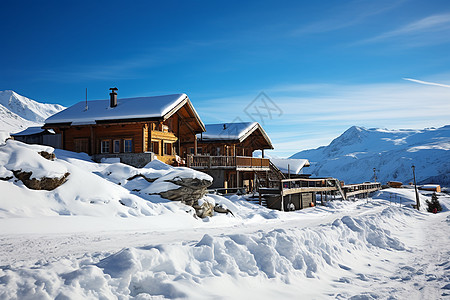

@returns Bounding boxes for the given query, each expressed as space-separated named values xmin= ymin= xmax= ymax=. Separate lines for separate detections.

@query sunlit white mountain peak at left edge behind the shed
xmin=0 ymin=90 xmax=65 ymax=133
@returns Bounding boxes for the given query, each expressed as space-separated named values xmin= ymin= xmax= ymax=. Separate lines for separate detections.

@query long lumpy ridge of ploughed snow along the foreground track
xmin=0 ymin=199 xmax=417 ymax=299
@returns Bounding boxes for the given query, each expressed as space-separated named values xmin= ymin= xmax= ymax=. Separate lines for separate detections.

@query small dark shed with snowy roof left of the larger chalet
xmin=11 ymin=126 xmax=61 ymax=148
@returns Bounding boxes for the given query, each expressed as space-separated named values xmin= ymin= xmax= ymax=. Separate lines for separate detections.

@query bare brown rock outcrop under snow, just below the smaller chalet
xmin=159 ymin=177 xmax=212 ymax=206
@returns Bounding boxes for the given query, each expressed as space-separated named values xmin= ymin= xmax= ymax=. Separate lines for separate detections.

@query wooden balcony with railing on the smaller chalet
xmin=187 ymin=155 xmax=270 ymax=171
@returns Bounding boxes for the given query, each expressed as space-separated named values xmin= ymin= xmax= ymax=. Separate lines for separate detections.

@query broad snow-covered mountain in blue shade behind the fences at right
xmin=291 ymin=125 xmax=450 ymax=186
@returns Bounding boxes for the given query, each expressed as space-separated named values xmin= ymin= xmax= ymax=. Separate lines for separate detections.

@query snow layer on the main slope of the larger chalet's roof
xmin=45 ymin=94 xmax=188 ymax=125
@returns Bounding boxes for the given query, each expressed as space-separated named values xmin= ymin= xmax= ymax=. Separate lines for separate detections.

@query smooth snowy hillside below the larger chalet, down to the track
xmin=0 ymin=140 xmax=211 ymax=218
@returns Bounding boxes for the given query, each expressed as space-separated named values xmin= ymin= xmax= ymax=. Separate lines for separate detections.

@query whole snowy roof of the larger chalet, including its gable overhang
xmin=44 ymin=94 xmax=205 ymax=132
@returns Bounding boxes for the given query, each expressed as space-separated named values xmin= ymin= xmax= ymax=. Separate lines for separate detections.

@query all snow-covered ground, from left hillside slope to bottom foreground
xmin=0 ymin=141 xmax=450 ymax=299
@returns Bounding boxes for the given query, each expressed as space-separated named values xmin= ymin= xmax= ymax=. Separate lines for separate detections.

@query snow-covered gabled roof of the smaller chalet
xmin=197 ymin=122 xmax=272 ymax=147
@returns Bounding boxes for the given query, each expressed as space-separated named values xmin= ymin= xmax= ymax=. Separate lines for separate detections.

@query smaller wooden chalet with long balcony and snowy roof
xmin=186 ymin=122 xmax=273 ymax=190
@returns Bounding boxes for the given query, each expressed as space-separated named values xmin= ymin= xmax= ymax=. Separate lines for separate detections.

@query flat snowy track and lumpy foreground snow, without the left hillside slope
xmin=0 ymin=190 xmax=450 ymax=299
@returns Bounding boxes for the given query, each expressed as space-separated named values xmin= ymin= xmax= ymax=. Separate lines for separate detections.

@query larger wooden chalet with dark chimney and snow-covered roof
xmin=43 ymin=88 xmax=205 ymax=167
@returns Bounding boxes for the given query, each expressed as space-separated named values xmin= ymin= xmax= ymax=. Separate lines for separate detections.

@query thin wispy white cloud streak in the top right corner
xmin=357 ymin=13 xmax=450 ymax=46
